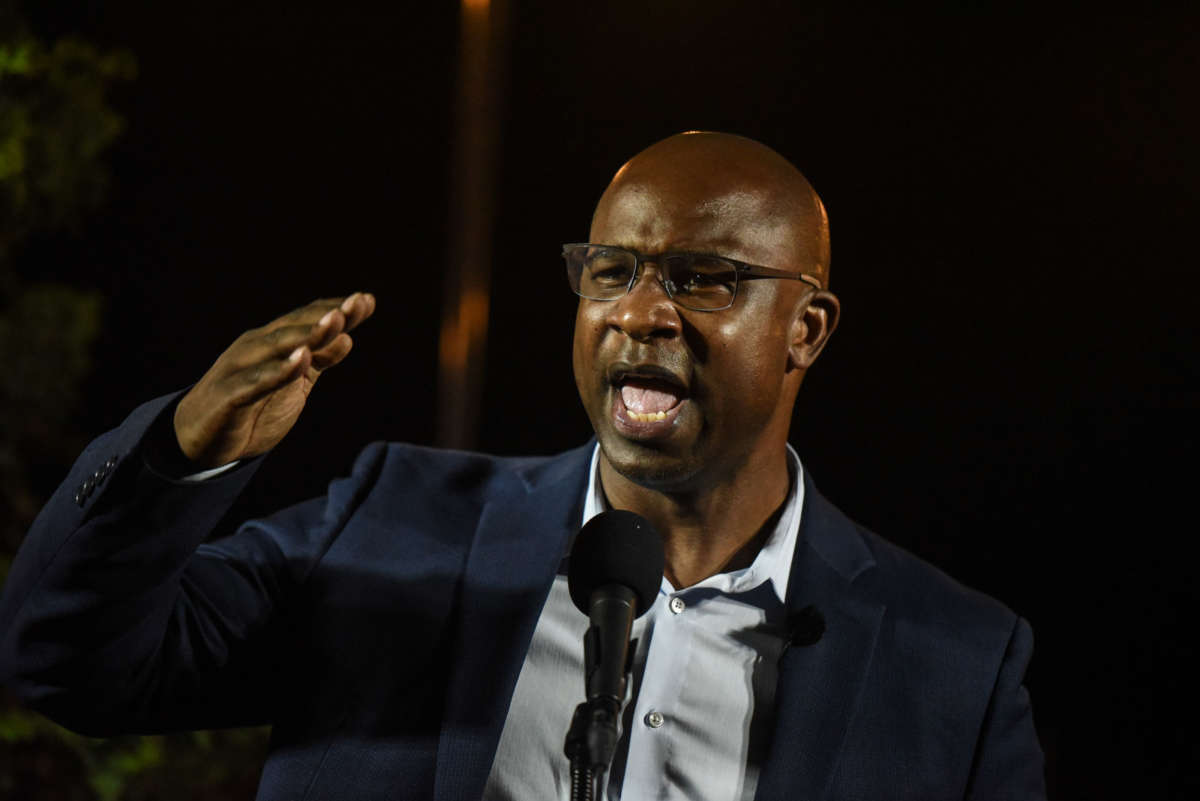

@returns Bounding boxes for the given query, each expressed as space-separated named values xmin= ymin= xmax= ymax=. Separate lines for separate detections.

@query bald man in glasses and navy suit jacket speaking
xmin=0 ymin=133 xmax=1044 ymax=800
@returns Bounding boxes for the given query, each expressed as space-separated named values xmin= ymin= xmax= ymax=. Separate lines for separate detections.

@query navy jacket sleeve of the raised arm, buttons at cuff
xmin=0 ymin=397 xmax=383 ymax=736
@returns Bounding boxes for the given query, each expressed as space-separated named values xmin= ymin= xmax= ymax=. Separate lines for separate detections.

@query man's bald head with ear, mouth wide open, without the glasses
xmin=574 ymin=132 xmax=839 ymax=492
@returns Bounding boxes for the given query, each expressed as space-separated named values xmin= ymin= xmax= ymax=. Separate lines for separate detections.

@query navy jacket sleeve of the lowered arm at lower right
xmin=966 ymin=618 xmax=1046 ymax=801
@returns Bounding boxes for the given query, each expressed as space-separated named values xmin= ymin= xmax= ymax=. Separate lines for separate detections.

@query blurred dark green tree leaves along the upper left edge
xmin=0 ymin=10 xmax=137 ymax=563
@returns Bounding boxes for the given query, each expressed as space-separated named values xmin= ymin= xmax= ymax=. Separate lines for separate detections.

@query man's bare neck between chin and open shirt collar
xmin=599 ymin=445 xmax=788 ymax=589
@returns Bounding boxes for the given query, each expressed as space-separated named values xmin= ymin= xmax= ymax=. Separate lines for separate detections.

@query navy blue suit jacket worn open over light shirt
xmin=0 ymin=398 xmax=1044 ymax=801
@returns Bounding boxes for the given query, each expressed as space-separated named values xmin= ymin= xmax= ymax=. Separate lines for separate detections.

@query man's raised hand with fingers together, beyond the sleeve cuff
xmin=175 ymin=293 xmax=374 ymax=468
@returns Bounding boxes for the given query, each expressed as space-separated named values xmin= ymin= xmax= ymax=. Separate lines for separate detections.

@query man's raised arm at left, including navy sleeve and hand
xmin=0 ymin=295 xmax=382 ymax=734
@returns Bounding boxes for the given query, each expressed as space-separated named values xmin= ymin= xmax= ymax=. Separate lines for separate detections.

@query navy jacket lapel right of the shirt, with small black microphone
xmin=755 ymin=472 xmax=886 ymax=801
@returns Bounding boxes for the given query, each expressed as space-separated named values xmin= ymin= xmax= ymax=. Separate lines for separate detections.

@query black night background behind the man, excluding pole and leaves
xmin=11 ymin=0 xmax=1200 ymax=799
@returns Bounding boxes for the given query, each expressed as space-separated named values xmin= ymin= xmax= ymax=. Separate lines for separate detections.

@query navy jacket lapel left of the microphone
xmin=433 ymin=444 xmax=592 ymax=801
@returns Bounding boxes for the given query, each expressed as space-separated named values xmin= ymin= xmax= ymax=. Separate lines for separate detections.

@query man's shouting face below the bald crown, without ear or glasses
xmin=574 ymin=176 xmax=803 ymax=492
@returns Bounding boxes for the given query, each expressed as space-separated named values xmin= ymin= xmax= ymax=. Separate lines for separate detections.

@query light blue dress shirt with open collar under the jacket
xmin=484 ymin=447 xmax=804 ymax=801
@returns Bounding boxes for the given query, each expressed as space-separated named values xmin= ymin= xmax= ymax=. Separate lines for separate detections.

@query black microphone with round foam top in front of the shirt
xmin=565 ymin=510 xmax=664 ymax=784
